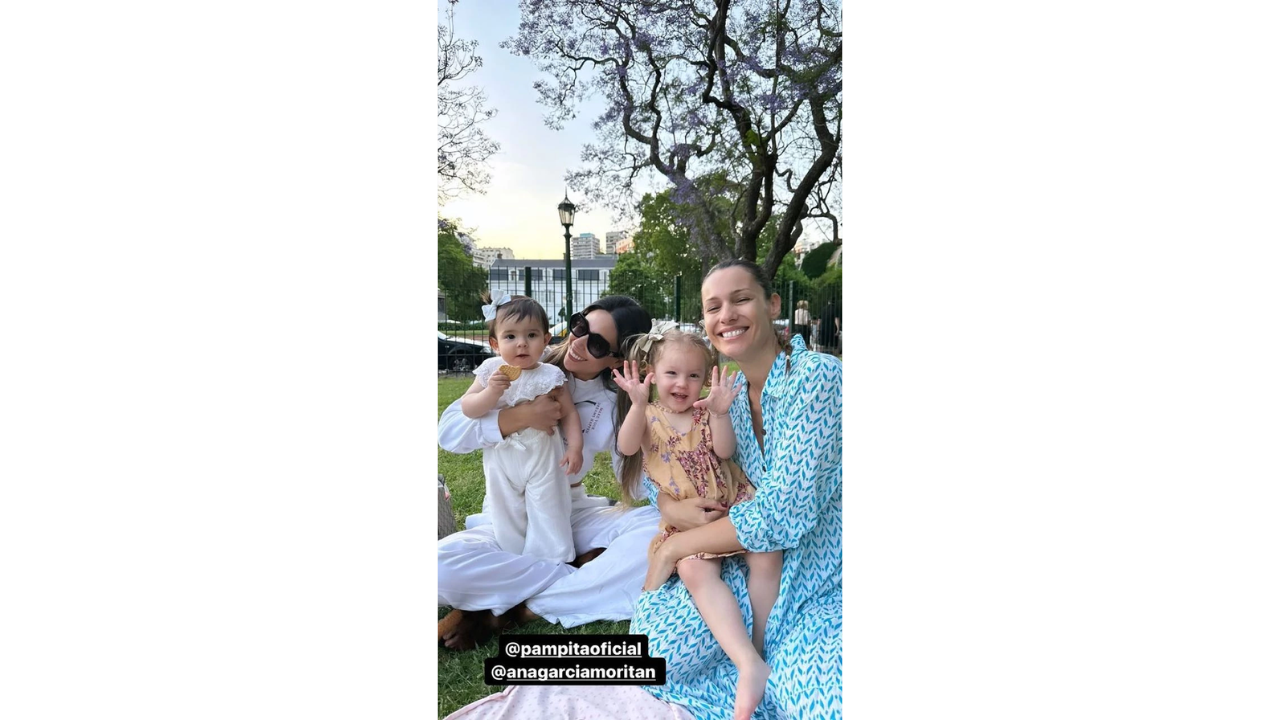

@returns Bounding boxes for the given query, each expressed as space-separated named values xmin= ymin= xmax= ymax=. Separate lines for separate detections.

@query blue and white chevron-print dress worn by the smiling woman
xmin=631 ymin=336 xmax=845 ymax=720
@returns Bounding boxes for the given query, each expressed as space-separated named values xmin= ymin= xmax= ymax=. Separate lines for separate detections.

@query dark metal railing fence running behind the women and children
xmin=435 ymin=268 xmax=845 ymax=375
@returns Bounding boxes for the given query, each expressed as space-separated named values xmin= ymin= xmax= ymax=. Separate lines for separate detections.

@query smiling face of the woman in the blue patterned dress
xmin=703 ymin=268 xmax=782 ymax=360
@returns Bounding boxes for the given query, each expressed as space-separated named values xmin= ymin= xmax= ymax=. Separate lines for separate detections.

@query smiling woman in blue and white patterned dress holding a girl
xmin=631 ymin=260 xmax=845 ymax=720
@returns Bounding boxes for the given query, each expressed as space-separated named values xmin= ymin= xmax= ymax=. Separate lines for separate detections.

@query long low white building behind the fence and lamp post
xmin=489 ymin=256 xmax=618 ymax=317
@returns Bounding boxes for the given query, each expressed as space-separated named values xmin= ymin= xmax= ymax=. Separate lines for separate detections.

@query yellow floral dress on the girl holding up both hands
xmin=644 ymin=402 xmax=755 ymax=560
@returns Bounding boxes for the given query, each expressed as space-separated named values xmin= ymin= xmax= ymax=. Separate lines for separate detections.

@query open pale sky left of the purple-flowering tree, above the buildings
xmin=440 ymin=0 xmax=660 ymax=260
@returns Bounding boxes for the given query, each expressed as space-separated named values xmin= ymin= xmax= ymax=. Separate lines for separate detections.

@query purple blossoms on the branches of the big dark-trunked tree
xmin=504 ymin=0 xmax=844 ymax=223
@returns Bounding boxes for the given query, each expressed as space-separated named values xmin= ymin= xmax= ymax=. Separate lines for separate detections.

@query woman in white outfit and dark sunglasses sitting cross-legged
xmin=435 ymin=296 xmax=723 ymax=650
